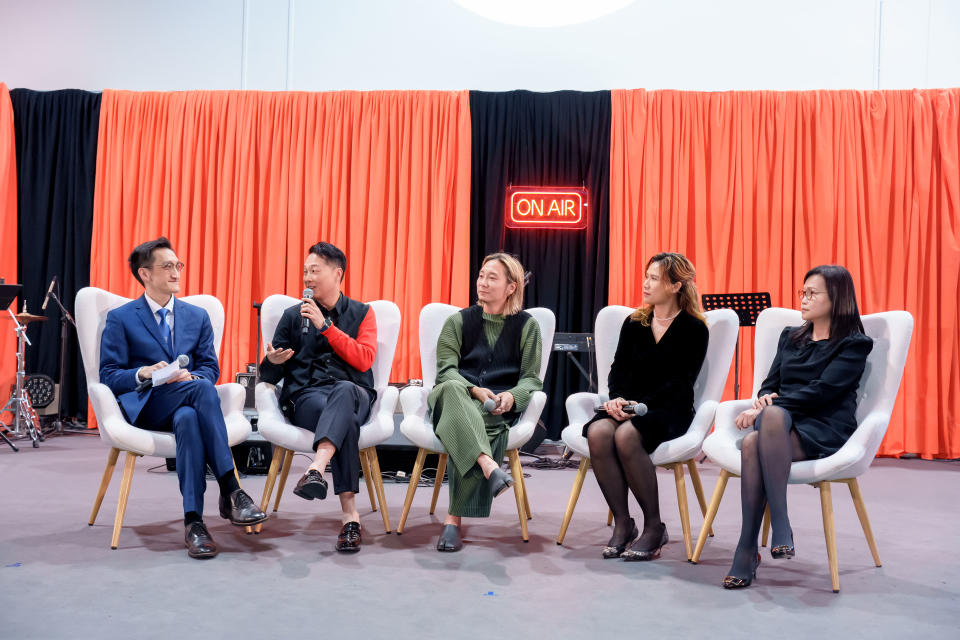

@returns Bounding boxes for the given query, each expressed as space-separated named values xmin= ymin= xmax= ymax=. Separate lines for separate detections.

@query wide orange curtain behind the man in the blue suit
xmin=90 ymin=91 xmax=470 ymax=381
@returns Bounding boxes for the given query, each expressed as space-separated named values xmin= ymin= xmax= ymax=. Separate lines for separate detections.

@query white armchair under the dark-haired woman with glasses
xmin=691 ymin=308 xmax=913 ymax=593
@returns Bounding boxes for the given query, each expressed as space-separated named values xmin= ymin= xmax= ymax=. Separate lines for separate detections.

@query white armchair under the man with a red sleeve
xmin=255 ymin=295 xmax=400 ymax=533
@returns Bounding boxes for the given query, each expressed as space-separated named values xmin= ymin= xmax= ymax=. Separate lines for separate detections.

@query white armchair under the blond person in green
xmin=397 ymin=302 xmax=557 ymax=542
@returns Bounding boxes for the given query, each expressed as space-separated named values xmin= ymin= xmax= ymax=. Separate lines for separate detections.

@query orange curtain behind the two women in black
xmin=609 ymin=89 xmax=960 ymax=458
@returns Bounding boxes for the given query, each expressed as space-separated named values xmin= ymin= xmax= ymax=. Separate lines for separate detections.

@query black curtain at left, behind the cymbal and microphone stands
xmin=10 ymin=89 xmax=100 ymax=417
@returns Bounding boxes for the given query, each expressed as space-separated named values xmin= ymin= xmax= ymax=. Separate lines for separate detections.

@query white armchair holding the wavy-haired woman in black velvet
xmin=557 ymin=306 xmax=740 ymax=558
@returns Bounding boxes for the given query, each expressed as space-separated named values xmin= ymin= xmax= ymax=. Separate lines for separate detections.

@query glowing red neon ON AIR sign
xmin=504 ymin=187 xmax=588 ymax=229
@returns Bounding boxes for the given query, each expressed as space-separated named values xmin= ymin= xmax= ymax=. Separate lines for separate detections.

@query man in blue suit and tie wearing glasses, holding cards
xmin=100 ymin=238 xmax=267 ymax=558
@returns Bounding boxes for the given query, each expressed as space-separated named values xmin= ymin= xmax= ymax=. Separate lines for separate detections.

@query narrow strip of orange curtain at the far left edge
xmin=0 ymin=82 xmax=17 ymax=406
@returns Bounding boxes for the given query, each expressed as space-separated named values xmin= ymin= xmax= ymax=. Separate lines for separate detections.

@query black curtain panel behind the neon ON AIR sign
xmin=470 ymin=91 xmax=610 ymax=439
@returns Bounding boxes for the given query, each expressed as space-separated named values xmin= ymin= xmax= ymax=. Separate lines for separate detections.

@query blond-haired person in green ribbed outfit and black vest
xmin=427 ymin=253 xmax=543 ymax=551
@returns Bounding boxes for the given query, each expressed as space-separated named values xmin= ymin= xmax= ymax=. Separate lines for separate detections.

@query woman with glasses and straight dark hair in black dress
xmin=723 ymin=265 xmax=873 ymax=589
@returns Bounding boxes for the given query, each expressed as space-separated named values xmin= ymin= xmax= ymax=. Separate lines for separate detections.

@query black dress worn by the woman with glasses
xmin=759 ymin=327 xmax=873 ymax=459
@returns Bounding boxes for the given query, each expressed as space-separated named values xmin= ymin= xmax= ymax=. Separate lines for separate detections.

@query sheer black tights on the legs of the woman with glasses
xmin=729 ymin=406 xmax=806 ymax=578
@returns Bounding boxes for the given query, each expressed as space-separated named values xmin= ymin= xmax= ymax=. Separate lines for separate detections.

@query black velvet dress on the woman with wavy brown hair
xmin=583 ymin=311 xmax=710 ymax=453
